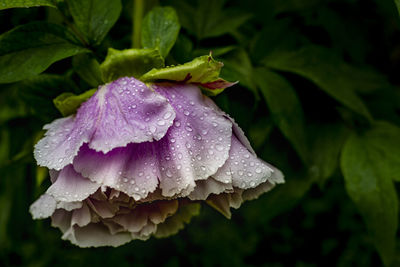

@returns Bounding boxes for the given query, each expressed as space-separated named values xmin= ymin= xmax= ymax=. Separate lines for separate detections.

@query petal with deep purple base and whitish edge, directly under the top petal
xmin=73 ymin=142 xmax=159 ymax=200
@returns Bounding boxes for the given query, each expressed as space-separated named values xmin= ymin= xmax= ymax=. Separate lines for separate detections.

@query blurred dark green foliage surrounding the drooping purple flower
xmin=0 ymin=0 xmax=400 ymax=267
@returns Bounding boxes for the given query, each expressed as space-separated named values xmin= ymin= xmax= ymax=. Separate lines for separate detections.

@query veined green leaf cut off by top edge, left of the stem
xmin=67 ymin=0 xmax=122 ymax=45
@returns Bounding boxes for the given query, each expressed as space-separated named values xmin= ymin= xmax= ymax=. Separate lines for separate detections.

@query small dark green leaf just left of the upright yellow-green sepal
xmin=72 ymin=54 xmax=104 ymax=87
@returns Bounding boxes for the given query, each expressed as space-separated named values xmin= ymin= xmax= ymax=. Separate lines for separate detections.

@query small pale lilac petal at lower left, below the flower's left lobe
xmin=47 ymin=165 xmax=101 ymax=202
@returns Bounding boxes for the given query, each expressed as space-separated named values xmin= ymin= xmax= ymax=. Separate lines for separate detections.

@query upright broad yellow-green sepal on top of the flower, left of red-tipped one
xmin=100 ymin=48 xmax=164 ymax=82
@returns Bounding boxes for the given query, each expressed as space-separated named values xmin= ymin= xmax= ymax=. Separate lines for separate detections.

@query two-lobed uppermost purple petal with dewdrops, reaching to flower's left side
xmin=34 ymin=78 xmax=175 ymax=170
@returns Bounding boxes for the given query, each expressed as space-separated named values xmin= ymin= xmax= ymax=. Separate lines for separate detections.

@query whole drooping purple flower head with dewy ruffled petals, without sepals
xmin=30 ymin=78 xmax=283 ymax=247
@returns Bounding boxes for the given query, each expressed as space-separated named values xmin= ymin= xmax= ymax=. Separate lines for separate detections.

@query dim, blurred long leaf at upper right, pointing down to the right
xmin=263 ymin=46 xmax=372 ymax=120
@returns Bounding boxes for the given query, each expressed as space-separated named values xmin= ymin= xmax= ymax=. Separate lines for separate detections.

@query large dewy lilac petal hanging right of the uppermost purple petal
xmin=154 ymin=84 xmax=232 ymax=196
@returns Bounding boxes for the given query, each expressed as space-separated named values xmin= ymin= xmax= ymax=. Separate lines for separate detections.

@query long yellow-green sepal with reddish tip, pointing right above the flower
xmin=140 ymin=54 xmax=235 ymax=96
